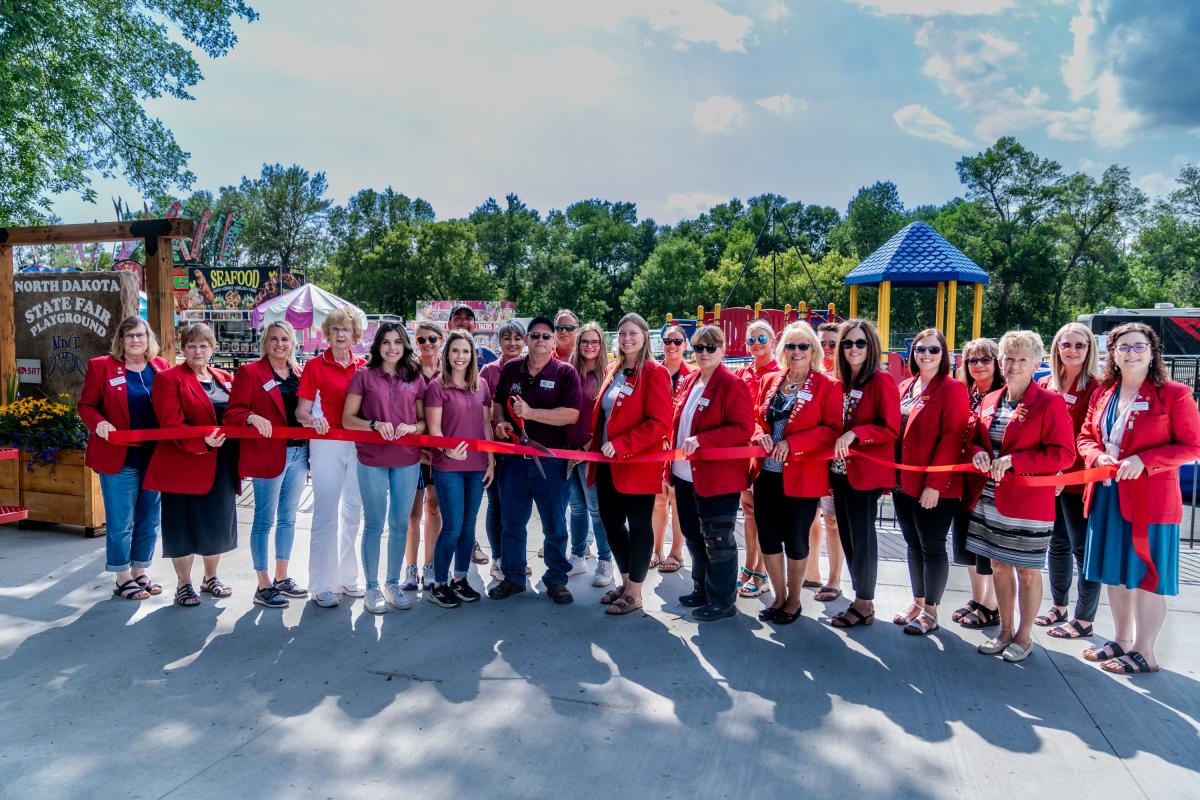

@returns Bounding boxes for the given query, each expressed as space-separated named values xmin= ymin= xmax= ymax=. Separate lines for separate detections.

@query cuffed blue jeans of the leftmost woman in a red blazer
xmin=100 ymin=467 xmax=162 ymax=572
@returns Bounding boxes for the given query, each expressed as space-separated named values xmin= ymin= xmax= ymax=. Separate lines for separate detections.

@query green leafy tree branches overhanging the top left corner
xmin=0 ymin=0 xmax=258 ymax=224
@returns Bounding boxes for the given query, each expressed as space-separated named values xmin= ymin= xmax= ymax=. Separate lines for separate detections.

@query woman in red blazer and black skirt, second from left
xmin=145 ymin=323 xmax=240 ymax=606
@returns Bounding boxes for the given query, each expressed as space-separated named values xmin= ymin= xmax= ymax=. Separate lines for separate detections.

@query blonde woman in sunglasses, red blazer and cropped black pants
xmin=754 ymin=323 xmax=841 ymax=625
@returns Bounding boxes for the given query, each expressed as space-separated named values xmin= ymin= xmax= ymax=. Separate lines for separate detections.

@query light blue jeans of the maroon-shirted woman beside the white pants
xmin=359 ymin=464 xmax=421 ymax=589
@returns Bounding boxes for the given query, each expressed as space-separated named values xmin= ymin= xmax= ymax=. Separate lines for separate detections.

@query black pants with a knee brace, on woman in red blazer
xmin=674 ymin=476 xmax=742 ymax=608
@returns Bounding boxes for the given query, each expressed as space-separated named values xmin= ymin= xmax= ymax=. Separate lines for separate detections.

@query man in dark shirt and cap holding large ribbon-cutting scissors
xmin=487 ymin=317 xmax=580 ymax=604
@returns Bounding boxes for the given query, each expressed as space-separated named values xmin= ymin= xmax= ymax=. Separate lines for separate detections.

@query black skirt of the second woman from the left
xmin=162 ymin=439 xmax=240 ymax=558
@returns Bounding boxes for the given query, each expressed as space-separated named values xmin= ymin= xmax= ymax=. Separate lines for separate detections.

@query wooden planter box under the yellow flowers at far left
xmin=0 ymin=450 xmax=104 ymax=536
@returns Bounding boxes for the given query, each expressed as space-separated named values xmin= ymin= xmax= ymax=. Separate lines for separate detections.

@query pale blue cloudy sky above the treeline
xmin=55 ymin=0 xmax=1200 ymax=223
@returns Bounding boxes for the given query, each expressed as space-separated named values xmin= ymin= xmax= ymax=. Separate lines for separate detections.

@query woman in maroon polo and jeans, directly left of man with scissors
xmin=425 ymin=331 xmax=496 ymax=608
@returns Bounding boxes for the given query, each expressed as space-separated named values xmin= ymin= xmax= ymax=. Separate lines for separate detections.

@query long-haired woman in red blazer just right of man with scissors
xmin=589 ymin=314 xmax=673 ymax=614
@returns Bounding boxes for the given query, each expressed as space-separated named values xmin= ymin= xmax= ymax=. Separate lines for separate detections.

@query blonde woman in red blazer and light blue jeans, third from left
xmin=224 ymin=321 xmax=312 ymax=608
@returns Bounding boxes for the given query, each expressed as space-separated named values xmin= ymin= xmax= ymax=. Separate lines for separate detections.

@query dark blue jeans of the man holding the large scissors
xmin=500 ymin=457 xmax=571 ymax=589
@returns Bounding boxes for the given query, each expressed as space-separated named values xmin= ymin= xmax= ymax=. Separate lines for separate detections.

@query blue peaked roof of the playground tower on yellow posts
xmin=846 ymin=222 xmax=989 ymax=287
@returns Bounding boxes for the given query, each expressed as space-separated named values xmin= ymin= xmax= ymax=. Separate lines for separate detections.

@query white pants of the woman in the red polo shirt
xmin=308 ymin=439 xmax=362 ymax=594
